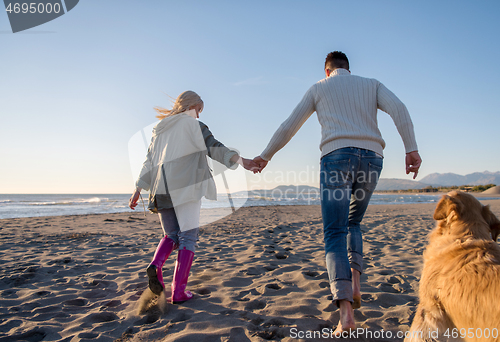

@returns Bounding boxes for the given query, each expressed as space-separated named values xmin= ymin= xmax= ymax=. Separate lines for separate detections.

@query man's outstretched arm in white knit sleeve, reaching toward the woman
xmin=260 ymin=87 xmax=316 ymax=161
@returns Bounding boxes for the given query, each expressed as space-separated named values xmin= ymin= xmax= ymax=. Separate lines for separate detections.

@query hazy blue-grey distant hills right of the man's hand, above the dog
xmin=420 ymin=171 xmax=500 ymax=186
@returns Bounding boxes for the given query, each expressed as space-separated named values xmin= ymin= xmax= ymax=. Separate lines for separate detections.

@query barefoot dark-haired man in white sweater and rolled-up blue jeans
xmin=254 ymin=51 xmax=421 ymax=333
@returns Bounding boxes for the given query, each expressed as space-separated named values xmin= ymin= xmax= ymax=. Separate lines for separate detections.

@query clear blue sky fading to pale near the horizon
xmin=0 ymin=0 xmax=500 ymax=193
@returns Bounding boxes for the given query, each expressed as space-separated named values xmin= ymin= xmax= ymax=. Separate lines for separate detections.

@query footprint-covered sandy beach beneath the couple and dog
xmin=0 ymin=200 xmax=500 ymax=342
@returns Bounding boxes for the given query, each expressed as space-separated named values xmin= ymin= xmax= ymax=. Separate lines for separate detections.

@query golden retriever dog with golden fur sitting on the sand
xmin=405 ymin=191 xmax=500 ymax=342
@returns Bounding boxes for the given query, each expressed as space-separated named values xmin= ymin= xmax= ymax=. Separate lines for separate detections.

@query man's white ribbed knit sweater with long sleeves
xmin=260 ymin=69 xmax=418 ymax=160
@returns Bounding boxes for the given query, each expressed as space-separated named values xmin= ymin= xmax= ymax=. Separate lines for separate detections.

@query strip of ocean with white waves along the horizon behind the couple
xmin=0 ymin=194 xmax=454 ymax=219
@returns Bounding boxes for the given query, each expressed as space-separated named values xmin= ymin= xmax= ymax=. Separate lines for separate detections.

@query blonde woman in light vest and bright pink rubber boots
xmin=129 ymin=90 xmax=260 ymax=303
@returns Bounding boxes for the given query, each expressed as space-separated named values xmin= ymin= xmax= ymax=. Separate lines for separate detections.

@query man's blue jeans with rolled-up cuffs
xmin=320 ymin=147 xmax=382 ymax=302
